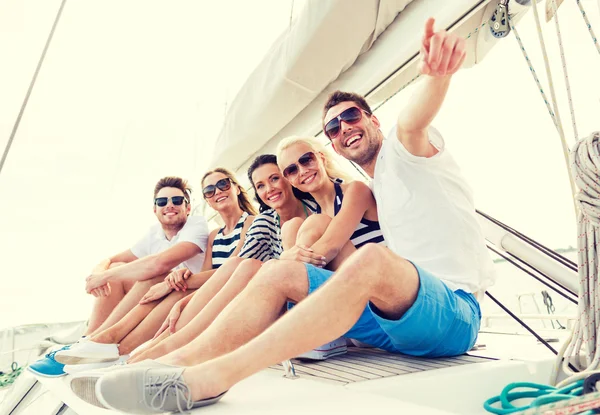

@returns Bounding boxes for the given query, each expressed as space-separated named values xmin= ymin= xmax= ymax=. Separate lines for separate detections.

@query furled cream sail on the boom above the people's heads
xmin=212 ymin=0 xmax=526 ymax=176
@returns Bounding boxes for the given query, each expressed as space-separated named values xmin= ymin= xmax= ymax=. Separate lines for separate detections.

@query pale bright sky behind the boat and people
xmin=0 ymin=0 xmax=600 ymax=329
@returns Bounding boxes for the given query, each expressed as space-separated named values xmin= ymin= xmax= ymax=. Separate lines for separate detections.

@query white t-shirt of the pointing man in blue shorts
xmin=372 ymin=127 xmax=495 ymax=295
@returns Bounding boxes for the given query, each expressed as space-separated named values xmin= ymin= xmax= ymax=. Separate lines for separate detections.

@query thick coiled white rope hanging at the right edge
xmin=552 ymin=132 xmax=600 ymax=384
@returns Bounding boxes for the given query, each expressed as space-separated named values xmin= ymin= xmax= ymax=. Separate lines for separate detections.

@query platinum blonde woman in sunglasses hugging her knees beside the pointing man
xmin=277 ymin=137 xmax=383 ymax=270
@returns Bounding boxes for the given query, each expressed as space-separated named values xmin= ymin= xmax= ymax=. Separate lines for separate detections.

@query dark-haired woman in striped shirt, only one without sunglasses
xmin=130 ymin=154 xmax=323 ymax=362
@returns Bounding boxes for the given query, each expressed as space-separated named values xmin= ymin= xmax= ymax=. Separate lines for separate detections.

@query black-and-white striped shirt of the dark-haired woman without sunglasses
xmin=238 ymin=200 xmax=318 ymax=262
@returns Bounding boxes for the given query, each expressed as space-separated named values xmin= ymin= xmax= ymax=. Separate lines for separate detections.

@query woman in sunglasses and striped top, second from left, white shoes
xmin=55 ymin=168 xmax=256 ymax=373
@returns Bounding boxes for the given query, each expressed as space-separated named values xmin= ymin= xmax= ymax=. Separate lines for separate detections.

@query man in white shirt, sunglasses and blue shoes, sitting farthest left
xmin=30 ymin=177 xmax=209 ymax=376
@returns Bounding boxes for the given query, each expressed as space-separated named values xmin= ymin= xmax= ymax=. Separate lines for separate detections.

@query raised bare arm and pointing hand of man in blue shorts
xmin=396 ymin=18 xmax=466 ymax=157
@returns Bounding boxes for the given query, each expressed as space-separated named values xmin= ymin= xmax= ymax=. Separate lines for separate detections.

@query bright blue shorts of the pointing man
xmin=305 ymin=264 xmax=481 ymax=357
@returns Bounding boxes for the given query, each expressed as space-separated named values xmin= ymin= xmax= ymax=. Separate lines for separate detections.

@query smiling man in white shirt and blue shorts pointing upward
xmin=76 ymin=19 xmax=493 ymax=413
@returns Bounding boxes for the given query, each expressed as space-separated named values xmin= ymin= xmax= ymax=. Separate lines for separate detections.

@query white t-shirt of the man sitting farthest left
xmin=131 ymin=216 xmax=208 ymax=274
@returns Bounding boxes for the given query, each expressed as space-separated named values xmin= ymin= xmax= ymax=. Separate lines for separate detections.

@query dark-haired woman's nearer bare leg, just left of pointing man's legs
xmin=130 ymin=259 xmax=262 ymax=363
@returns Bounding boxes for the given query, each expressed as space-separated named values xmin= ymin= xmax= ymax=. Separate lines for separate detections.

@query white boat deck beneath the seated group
xmin=0 ymin=333 xmax=566 ymax=415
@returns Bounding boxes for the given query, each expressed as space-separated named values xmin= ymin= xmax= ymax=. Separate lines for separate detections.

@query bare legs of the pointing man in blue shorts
xmin=176 ymin=244 xmax=419 ymax=400
